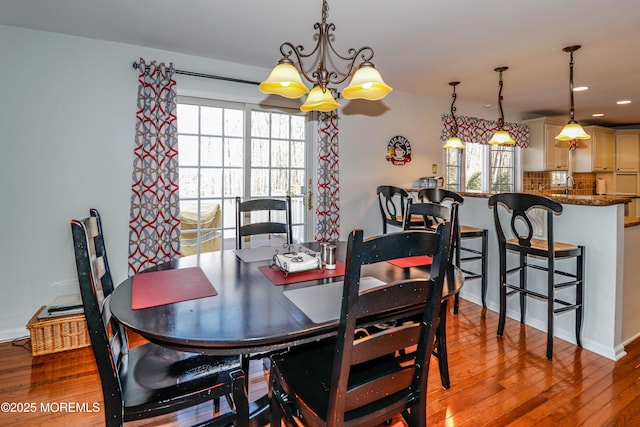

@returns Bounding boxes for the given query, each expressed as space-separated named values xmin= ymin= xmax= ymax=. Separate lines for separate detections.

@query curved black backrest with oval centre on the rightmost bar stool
xmin=489 ymin=193 xmax=562 ymax=247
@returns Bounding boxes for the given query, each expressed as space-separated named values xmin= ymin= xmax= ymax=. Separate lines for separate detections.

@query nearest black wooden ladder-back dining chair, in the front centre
xmin=269 ymin=223 xmax=450 ymax=426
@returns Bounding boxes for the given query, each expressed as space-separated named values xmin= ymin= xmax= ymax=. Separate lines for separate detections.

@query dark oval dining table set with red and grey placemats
xmin=110 ymin=242 xmax=464 ymax=424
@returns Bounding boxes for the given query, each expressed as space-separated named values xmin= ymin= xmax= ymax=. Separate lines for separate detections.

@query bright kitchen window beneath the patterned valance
xmin=445 ymin=143 xmax=519 ymax=193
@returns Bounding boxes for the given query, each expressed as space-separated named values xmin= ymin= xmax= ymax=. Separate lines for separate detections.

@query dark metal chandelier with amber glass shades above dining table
xmin=259 ymin=0 xmax=393 ymax=112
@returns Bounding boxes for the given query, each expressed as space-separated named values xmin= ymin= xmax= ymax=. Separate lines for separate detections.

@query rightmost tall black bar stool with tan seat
xmin=489 ymin=193 xmax=584 ymax=360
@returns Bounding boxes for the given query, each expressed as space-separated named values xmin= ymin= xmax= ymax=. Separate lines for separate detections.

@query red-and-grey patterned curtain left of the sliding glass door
xmin=129 ymin=59 xmax=180 ymax=275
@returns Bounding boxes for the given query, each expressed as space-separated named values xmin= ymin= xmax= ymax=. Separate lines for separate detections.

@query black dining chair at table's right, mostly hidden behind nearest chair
xmin=403 ymin=203 xmax=458 ymax=390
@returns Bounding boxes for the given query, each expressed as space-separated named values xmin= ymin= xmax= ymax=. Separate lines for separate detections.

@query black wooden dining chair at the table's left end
xmin=71 ymin=210 xmax=249 ymax=426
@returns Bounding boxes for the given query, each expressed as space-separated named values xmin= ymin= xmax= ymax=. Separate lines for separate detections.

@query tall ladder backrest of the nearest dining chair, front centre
xmin=327 ymin=226 xmax=450 ymax=425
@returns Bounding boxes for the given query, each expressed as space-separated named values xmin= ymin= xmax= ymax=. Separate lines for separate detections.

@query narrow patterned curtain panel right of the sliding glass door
xmin=314 ymin=113 xmax=340 ymax=242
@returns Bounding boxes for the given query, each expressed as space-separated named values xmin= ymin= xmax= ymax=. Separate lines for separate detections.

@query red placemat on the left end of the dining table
xmin=131 ymin=267 xmax=218 ymax=310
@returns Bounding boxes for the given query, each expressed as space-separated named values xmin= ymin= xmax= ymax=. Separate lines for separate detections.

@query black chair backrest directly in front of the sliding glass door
xmin=236 ymin=196 xmax=293 ymax=249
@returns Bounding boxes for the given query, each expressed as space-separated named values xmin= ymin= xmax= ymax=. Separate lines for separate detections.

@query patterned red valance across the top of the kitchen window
xmin=440 ymin=114 xmax=529 ymax=148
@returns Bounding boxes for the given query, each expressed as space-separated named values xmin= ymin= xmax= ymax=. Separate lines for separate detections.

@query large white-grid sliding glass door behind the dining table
xmin=178 ymin=98 xmax=309 ymax=255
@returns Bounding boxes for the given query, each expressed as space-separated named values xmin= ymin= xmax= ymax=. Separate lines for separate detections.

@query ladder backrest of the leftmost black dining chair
xmin=71 ymin=214 xmax=129 ymax=422
